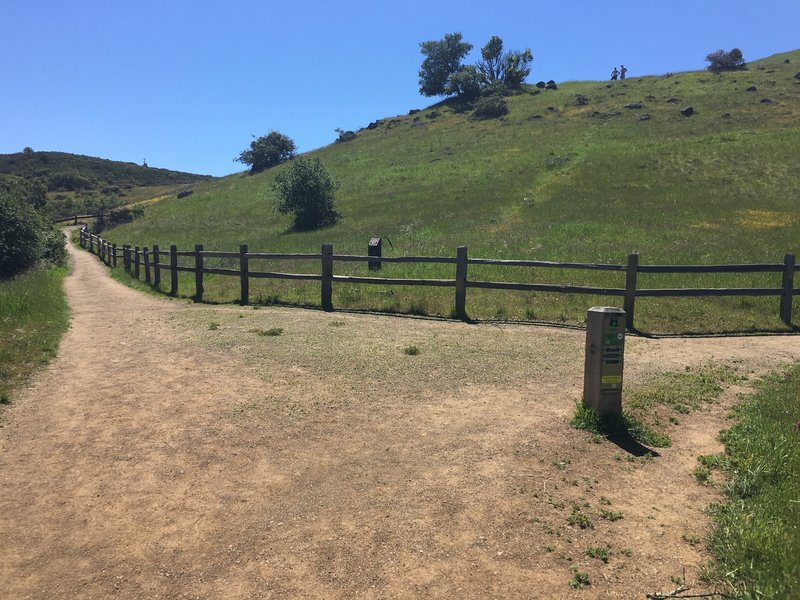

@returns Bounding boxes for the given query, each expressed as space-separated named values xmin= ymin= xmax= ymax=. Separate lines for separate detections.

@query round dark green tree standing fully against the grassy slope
xmin=272 ymin=158 xmax=341 ymax=231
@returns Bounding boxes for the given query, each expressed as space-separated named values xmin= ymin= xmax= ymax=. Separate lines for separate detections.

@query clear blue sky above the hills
xmin=0 ymin=0 xmax=800 ymax=175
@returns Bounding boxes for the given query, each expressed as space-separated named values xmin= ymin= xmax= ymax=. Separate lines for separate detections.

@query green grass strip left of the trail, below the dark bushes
xmin=0 ymin=266 xmax=69 ymax=404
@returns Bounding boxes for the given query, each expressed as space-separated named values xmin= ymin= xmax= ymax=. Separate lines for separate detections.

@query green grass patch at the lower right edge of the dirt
xmin=705 ymin=365 xmax=800 ymax=598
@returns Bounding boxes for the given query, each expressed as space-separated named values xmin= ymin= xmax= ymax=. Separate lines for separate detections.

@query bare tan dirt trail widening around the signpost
xmin=0 ymin=241 xmax=800 ymax=599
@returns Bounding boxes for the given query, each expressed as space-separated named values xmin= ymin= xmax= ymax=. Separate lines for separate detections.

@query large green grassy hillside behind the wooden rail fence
xmin=100 ymin=51 xmax=800 ymax=331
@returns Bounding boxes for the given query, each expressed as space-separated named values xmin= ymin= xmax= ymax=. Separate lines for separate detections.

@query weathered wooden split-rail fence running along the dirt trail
xmin=80 ymin=226 xmax=800 ymax=329
